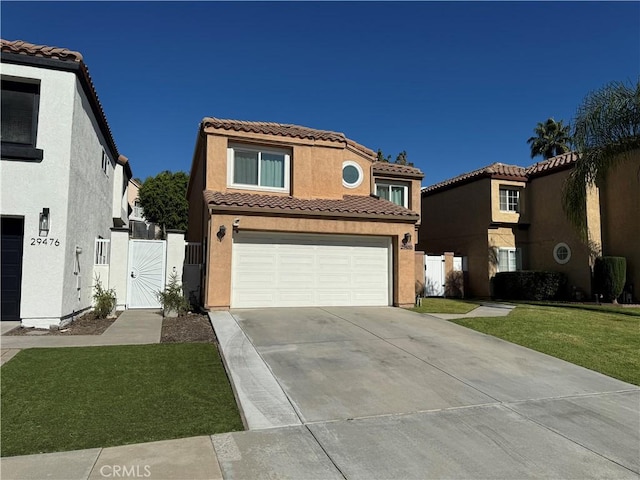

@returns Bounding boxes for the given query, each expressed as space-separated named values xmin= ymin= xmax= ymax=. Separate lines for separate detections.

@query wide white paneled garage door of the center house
xmin=231 ymin=232 xmax=390 ymax=308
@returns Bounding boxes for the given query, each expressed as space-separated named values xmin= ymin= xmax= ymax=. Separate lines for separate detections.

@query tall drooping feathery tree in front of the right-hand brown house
xmin=562 ymin=79 xmax=640 ymax=240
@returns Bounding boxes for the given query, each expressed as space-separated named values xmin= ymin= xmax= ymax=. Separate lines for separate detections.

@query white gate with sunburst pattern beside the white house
xmin=127 ymin=240 xmax=166 ymax=308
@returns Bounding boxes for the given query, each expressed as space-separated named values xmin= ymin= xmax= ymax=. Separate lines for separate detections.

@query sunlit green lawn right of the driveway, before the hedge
xmin=452 ymin=305 xmax=640 ymax=385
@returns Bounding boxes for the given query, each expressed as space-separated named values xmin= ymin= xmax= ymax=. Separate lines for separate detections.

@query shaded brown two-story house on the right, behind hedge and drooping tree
xmin=417 ymin=153 xmax=640 ymax=298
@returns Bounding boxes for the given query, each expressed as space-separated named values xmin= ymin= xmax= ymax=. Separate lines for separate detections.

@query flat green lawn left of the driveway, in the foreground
xmin=1 ymin=344 xmax=243 ymax=456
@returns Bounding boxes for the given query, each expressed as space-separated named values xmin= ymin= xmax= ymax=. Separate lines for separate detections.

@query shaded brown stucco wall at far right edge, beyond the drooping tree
xmin=600 ymin=150 xmax=640 ymax=301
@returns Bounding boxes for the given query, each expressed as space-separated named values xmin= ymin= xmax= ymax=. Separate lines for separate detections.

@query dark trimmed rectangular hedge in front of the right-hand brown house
xmin=493 ymin=270 xmax=567 ymax=300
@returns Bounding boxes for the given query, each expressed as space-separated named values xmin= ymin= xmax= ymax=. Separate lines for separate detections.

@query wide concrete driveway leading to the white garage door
xmin=213 ymin=307 xmax=640 ymax=479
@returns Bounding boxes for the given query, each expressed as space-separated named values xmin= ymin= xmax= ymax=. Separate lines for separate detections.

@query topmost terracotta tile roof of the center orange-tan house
xmin=201 ymin=117 xmax=374 ymax=157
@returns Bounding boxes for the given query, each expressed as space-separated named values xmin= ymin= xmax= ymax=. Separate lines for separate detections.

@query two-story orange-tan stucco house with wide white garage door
xmin=187 ymin=118 xmax=423 ymax=309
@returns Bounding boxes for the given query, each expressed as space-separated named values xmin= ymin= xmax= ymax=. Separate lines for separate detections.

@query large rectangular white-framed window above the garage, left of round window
xmin=227 ymin=145 xmax=291 ymax=192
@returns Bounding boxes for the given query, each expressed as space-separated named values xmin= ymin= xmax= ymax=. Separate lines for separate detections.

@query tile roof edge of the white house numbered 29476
xmin=0 ymin=39 xmax=124 ymax=169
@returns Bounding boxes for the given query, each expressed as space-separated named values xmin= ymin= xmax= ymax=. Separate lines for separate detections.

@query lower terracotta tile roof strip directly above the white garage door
xmin=204 ymin=190 xmax=419 ymax=221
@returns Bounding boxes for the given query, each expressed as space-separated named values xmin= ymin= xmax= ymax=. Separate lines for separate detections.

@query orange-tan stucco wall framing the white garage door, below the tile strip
xmin=204 ymin=212 xmax=416 ymax=309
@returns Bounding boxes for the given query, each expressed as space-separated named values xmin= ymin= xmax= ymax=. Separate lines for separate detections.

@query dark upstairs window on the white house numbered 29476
xmin=0 ymin=80 xmax=43 ymax=161
